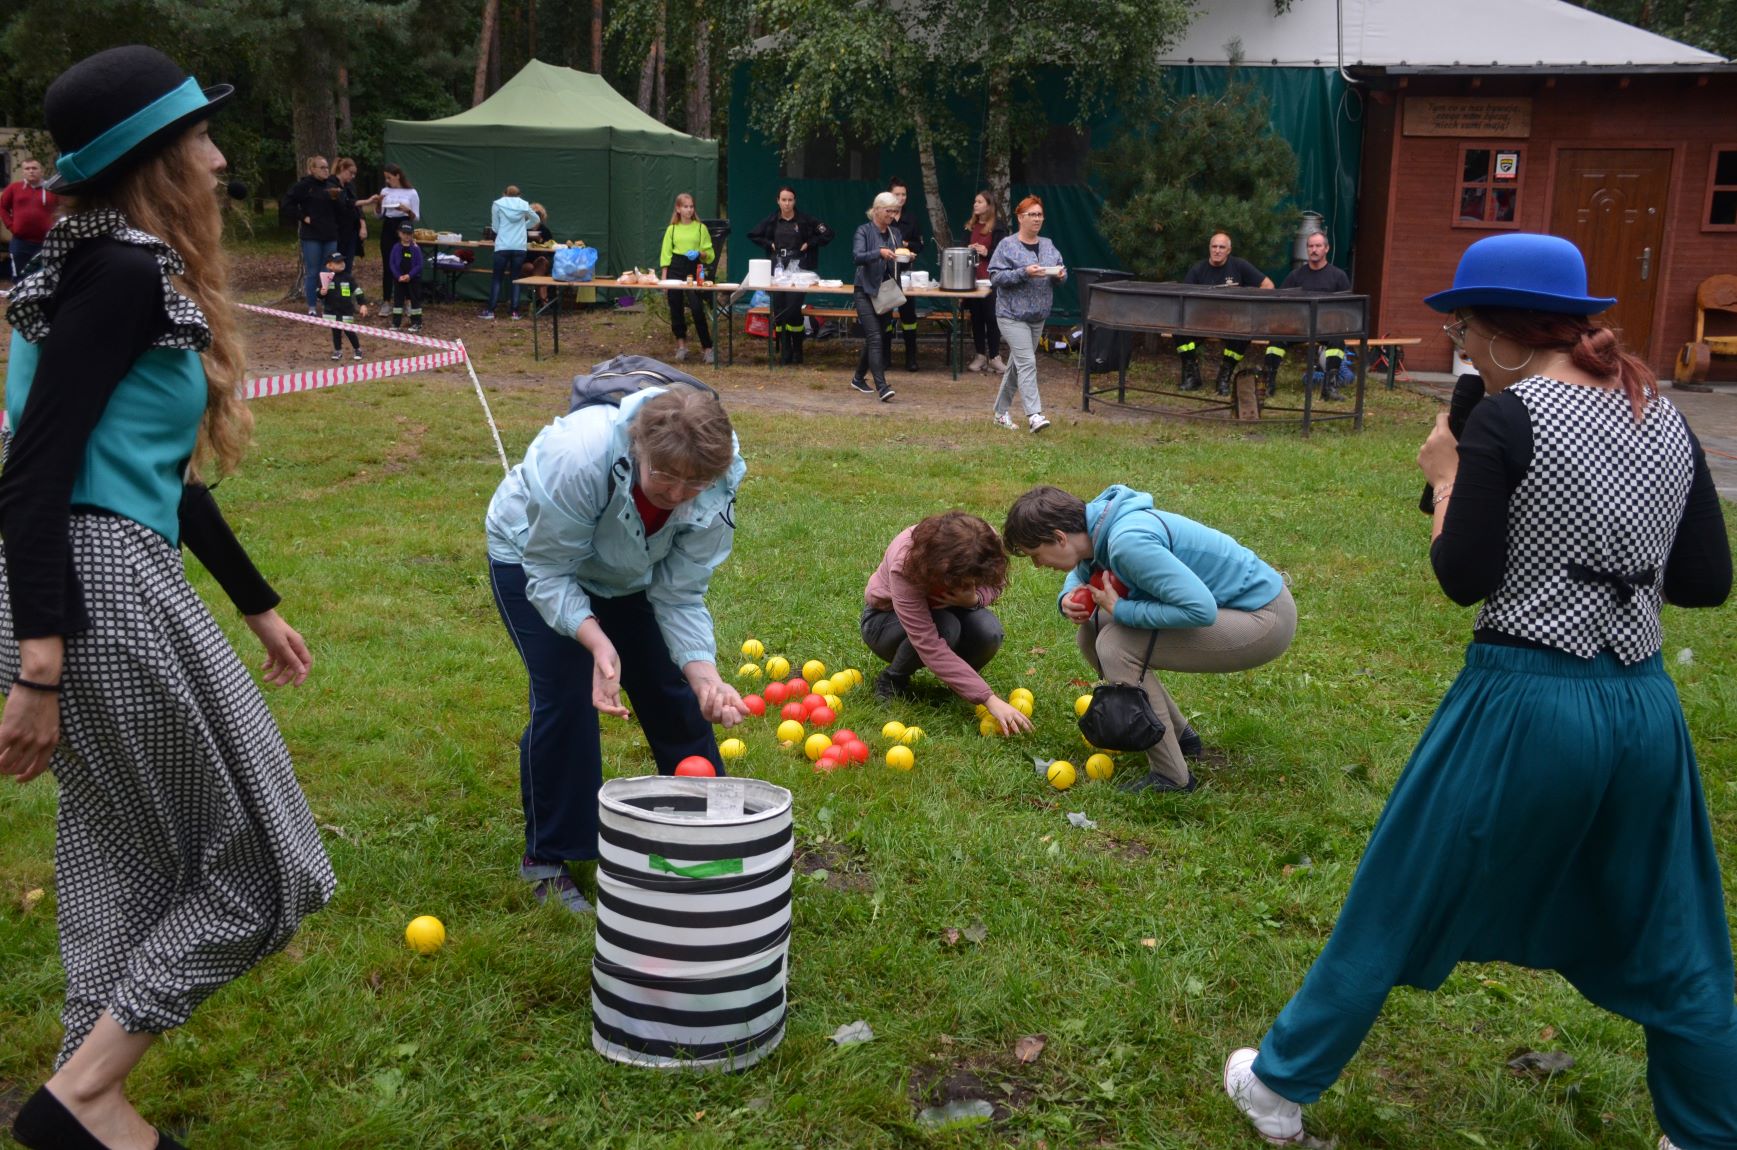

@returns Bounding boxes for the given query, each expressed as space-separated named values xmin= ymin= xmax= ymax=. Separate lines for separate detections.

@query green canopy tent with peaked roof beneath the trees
xmin=386 ymin=59 xmax=717 ymax=286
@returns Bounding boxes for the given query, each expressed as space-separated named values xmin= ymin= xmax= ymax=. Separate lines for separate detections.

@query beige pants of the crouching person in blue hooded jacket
xmin=1077 ymin=587 xmax=1298 ymax=783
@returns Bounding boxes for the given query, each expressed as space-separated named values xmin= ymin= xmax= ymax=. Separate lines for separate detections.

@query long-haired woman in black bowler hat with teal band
xmin=0 ymin=47 xmax=334 ymax=1150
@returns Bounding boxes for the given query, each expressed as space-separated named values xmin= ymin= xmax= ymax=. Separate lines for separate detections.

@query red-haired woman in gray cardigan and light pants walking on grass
xmin=988 ymin=196 xmax=1068 ymax=431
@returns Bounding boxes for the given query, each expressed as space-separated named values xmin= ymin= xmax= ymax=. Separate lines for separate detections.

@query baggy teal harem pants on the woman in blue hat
xmin=1254 ymin=643 xmax=1737 ymax=1150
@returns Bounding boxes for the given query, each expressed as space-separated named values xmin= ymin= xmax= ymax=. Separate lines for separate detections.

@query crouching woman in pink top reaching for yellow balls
xmin=862 ymin=511 xmax=1032 ymax=735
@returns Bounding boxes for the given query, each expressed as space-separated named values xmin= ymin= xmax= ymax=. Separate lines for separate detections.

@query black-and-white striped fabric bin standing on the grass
xmin=591 ymin=775 xmax=794 ymax=1070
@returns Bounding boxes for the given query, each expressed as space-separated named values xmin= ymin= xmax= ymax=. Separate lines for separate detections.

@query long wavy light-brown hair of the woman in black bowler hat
xmin=66 ymin=129 xmax=254 ymax=476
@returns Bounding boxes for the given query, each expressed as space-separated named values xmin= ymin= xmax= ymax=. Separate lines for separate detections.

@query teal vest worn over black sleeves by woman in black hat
xmin=5 ymin=332 xmax=207 ymax=545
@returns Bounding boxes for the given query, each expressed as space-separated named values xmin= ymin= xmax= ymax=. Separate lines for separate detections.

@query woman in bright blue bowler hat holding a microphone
xmin=1225 ymin=235 xmax=1737 ymax=1150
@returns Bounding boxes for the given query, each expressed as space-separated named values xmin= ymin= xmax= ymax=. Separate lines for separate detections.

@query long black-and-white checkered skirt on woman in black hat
xmin=0 ymin=514 xmax=335 ymax=1065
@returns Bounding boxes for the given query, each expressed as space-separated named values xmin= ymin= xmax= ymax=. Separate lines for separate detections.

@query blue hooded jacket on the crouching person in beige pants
xmin=1056 ymin=483 xmax=1285 ymax=631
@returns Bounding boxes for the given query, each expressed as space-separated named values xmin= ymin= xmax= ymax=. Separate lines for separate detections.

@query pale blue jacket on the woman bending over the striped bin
xmin=486 ymin=387 xmax=747 ymax=667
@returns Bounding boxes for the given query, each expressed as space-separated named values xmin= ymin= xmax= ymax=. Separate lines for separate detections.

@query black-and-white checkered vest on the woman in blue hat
xmin=1476 ymin=375 xmax=1694 ymax=664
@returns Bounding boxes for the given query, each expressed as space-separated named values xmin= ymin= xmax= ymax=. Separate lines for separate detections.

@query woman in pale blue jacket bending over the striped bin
xmin=486 ymin=386 xmax=747 ymax=914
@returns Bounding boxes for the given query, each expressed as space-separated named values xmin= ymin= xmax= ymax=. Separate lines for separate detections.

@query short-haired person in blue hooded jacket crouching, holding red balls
xmin=1002 ymin=483 xmax=1298 ymax=790
